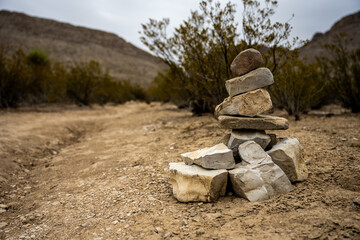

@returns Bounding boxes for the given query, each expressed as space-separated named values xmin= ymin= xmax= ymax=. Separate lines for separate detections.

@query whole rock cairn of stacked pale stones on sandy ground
xmin=169 ymin=49 xmax=308 ymax=202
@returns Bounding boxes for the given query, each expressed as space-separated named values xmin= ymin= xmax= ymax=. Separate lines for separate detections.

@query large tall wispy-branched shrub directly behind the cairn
xmin=141 ymin=0 xmax=291 ymax=113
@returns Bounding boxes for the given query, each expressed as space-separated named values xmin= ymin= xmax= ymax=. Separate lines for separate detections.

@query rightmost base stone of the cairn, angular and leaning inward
xmin=267 ymin=138 xmax=308 ymax=182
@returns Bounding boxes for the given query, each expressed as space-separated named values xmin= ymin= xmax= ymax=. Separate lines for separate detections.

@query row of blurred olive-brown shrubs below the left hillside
xmin=0 ymin=46 xmax=147 ymax=108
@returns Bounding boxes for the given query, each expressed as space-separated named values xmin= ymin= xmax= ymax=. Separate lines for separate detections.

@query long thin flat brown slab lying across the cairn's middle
xmin=218 ymin=115 xmax=289 ymax=130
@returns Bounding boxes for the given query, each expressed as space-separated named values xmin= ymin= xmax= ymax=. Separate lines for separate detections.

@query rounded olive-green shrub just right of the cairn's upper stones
xmin=270 ymin=53 xmax=326 ymax=120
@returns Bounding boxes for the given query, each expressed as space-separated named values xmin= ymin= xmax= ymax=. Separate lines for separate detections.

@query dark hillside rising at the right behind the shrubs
xmin=300 ymin=11 xmax=360 ymax=60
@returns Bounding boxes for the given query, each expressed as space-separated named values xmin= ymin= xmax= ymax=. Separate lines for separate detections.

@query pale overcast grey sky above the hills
xmin=0 ymin=0 xmax=360 ymax=49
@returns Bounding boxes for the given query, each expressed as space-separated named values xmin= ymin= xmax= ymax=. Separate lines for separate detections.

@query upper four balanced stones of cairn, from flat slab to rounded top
xmin=215 ymin=49 xmax=289 ymax=130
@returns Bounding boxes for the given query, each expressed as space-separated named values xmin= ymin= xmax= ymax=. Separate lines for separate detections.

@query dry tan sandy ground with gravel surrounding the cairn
xmin=0 ymin=103 xmax=360 ymax=240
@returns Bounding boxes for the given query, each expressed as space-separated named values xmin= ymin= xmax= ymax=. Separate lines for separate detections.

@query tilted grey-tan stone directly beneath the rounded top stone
xmin=225 ymin=68 xmax=274 ymax=97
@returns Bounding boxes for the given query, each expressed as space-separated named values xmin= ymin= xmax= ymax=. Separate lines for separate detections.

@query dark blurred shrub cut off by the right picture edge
xmin=318 ymin=34 xmax=360 ymax=112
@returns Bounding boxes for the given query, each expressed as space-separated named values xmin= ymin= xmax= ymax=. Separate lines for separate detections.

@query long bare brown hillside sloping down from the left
xmin=0 ymin=10 xmax=165 ymax=87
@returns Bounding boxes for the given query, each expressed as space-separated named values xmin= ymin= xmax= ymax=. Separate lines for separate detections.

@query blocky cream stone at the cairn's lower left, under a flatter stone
xmin=169 ymin=163 xmax=228 ymax=202
